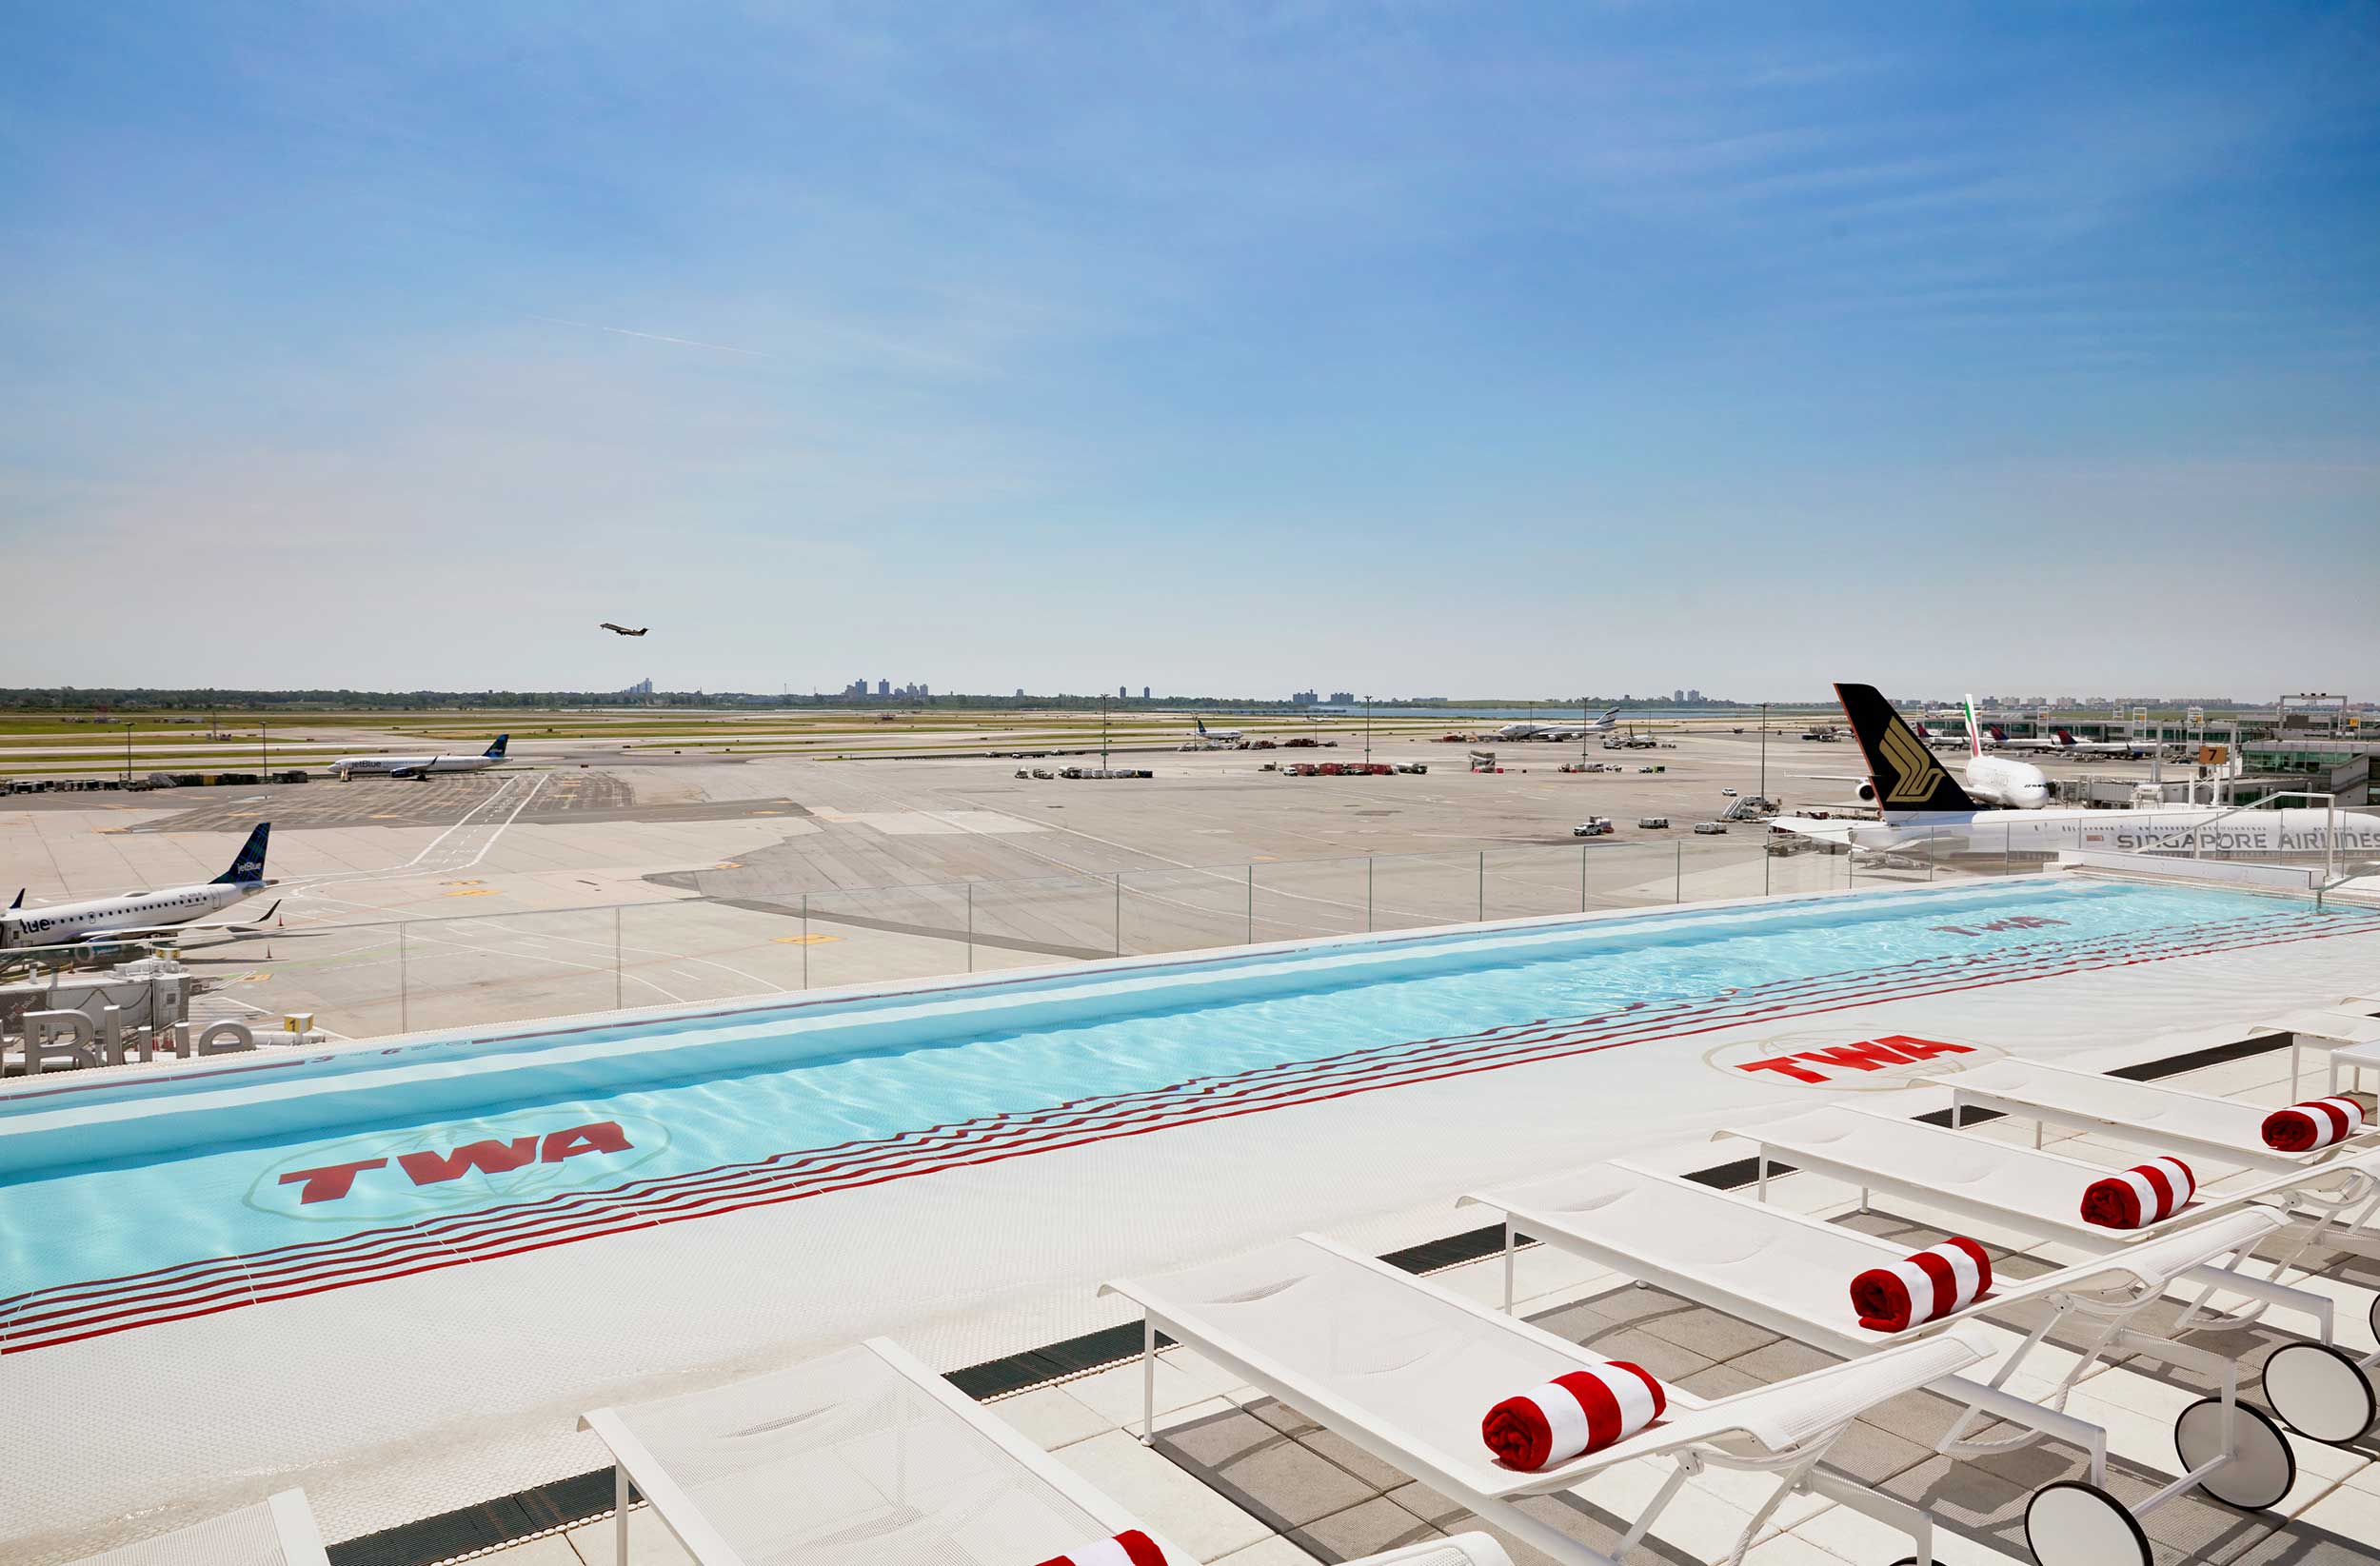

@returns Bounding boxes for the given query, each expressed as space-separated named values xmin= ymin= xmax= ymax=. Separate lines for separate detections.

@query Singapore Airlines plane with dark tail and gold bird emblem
xmin=1769 ymin=685 xmax=2380 ymax=855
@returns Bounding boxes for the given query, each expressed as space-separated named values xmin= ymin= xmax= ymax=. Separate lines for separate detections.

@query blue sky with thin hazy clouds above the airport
xmin=0 ymin=0 xmax=2380 ymax=700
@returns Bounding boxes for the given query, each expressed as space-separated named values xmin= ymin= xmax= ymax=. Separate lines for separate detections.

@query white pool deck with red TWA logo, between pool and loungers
xmin=0 ymin=871 xmax=2380 ymax=1566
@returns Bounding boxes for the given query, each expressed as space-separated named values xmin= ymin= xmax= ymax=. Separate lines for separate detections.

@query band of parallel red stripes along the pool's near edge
xmin=0 ymin=917 xmax=2373 ymax=1355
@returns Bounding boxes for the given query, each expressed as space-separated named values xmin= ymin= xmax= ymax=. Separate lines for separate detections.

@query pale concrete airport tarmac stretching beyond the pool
xmin=0 ymin=731 xmax=2161 ymax=1038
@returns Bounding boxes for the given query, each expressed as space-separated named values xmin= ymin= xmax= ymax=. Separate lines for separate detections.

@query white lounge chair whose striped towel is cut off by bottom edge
xmin=579 ymin=1338 xmax=1512 ymax=1566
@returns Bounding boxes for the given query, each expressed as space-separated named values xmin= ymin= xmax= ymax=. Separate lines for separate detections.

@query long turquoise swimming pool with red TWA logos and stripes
xmin=0 ymin=879 xmax=2380 ymax=1352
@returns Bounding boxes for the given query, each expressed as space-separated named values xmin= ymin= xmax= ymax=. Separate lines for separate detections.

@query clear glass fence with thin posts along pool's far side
xmin=214 ymin=823 xmax=2085 ymax=1038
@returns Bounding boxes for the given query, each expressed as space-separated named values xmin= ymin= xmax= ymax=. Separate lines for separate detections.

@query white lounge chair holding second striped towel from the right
xmin=1718 ymin=1104 xmax=2380 ymax=1442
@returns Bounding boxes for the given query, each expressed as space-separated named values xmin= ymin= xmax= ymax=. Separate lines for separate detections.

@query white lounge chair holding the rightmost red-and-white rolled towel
xmin=1918 ymin=1060 xmax=2380 ymax=1174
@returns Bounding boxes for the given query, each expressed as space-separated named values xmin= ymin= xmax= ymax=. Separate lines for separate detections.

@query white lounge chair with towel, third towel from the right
xmin=1464 ymin=1164 xmax=2297 ymax=1566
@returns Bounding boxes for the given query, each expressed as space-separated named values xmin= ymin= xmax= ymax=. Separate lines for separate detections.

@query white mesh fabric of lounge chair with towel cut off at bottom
xmin=617 ymin=1347 xmax=1114 ymax=1566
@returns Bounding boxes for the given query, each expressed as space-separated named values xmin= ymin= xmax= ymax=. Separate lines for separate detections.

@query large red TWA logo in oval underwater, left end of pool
xmin=248 ymin=1112 xmax=669 ymax=1223
